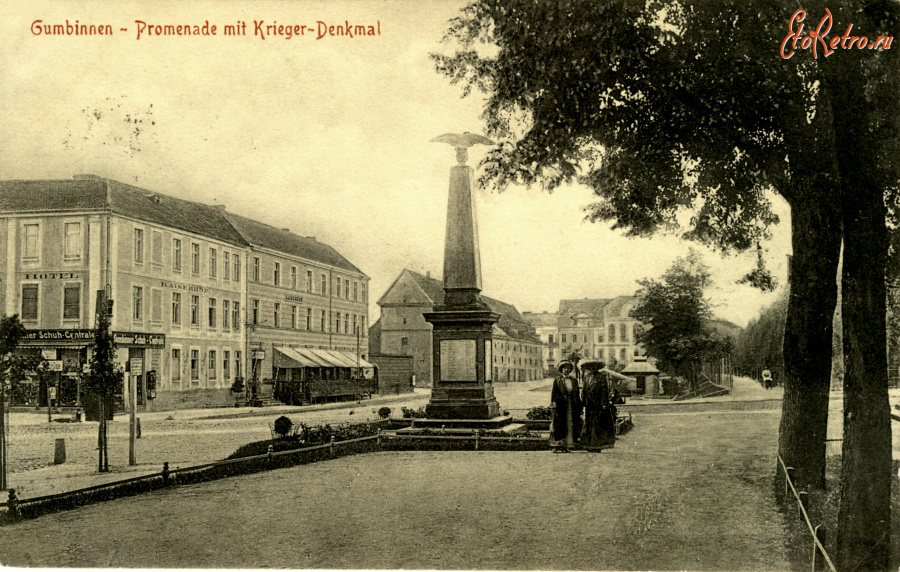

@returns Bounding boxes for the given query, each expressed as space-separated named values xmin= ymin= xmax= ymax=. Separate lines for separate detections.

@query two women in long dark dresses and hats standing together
xmin=550 ymin=360 xmax=616 ymax=452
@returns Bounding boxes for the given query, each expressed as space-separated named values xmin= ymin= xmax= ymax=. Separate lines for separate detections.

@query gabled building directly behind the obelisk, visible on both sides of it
xmin=370 ymin=269 xmax=543 ymax=387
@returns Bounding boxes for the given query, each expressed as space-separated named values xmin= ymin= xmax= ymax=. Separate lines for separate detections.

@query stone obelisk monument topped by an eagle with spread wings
xmin=424 ymin=133 xmax=508 ymax=427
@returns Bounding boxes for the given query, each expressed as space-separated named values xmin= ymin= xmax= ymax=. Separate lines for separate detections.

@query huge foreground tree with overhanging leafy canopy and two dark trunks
xmin=435 ymin=0 xmax=900 ymax=568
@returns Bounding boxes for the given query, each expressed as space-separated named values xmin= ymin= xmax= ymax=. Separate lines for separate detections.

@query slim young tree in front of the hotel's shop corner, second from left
xmin=84 ymin=290 xmax=123 ymax=473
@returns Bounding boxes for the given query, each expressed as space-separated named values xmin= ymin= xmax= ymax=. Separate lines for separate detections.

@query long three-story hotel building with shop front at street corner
xmin=0 ymin=175 xmax=368 ymax=410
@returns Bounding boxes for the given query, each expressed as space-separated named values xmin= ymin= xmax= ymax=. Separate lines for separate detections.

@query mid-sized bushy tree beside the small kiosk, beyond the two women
xmin=631 ymin=249 xmax=730 ymax=391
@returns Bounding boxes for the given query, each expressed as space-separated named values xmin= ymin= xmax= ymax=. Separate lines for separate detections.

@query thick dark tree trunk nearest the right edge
xmin=829 ymin=34 xmax=897 ymax=570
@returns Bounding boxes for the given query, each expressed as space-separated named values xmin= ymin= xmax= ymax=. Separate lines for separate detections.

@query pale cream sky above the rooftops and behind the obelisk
xmin=0 ymin=0 xmax=790 ymax=326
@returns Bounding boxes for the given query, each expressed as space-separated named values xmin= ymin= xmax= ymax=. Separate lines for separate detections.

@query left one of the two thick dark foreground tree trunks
xmin=775 ymin=94 xmax=841 ymax=497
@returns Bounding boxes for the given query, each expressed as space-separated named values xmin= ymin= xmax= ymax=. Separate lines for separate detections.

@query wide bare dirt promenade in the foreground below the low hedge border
xmin=0 ymin=411 xmax=788 ymax=570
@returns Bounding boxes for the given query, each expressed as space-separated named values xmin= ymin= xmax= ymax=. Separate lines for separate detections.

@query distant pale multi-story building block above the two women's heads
xmin=525 ymin=296 xmax=643 ymax=366
